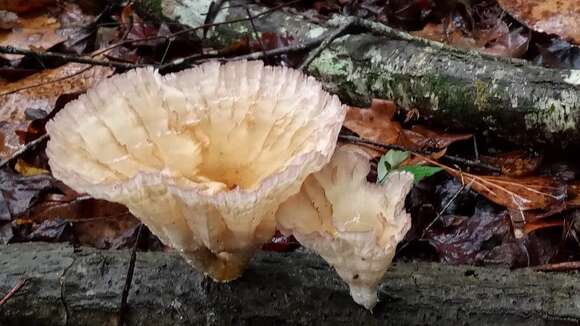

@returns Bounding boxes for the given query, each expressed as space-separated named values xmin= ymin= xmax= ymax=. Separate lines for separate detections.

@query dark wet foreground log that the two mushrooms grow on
xmin=0 ymin=243 xmax=580 ymax=326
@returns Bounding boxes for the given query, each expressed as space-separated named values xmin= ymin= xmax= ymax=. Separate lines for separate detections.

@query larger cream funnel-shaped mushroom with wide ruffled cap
xmin=47 ymin=61 xmax=345 ymax=281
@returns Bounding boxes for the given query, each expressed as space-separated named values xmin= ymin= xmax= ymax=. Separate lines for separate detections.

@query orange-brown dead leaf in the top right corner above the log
xmin=498 ymin=0 xmax=580 ymax=44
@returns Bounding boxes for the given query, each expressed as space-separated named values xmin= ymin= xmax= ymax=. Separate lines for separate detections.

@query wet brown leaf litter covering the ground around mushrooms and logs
xmin=0 ymin=0 xmax=580 ymax=267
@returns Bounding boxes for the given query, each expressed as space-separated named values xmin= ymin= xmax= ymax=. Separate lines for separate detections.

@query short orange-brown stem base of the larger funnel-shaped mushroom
xmin=181 ymin=247 xmax=253 ymax=282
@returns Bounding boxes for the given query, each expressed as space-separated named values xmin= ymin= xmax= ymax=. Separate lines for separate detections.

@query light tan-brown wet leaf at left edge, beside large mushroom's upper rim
xmin=0 ymin=63 xmax=113 ymax=160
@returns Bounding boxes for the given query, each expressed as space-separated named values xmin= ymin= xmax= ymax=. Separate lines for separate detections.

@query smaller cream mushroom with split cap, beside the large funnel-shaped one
xmin=276 ymin=147 xmax=413 ymax=309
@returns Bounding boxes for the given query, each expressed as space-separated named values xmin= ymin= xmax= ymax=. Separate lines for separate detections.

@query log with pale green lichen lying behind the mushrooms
xmin=138 ymin=0 xmax=580 ymax=147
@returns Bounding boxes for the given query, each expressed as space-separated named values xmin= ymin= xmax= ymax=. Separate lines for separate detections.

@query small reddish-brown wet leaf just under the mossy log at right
xmin=479 ymin=150 xmax=543 ymax=177
